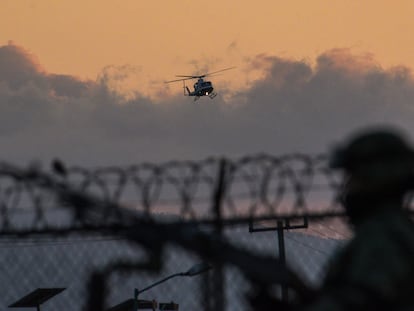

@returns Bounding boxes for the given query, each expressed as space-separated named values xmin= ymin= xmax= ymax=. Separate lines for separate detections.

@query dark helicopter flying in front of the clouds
xmin=165 ymin=67 xmax=236 ymax=101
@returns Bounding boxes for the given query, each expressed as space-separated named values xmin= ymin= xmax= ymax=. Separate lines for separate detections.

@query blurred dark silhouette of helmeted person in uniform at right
xmin=300 ymin=131 xmax=414 ymax=311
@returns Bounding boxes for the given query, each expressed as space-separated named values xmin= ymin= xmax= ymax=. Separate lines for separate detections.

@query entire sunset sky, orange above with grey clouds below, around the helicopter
xmin=0 ymin=0 xmax=414 ymax=165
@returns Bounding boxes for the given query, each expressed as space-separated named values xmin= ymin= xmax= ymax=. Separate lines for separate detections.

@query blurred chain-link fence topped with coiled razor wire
xmin=0 ymin=155 xmax=368 ymax=311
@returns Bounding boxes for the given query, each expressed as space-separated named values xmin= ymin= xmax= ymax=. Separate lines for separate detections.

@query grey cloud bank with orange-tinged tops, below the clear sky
xmin=0 ymin=44 xmax=414 ymax=166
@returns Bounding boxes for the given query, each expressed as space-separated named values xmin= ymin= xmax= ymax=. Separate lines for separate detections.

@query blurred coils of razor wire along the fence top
xmin=0 ymin=154 xmax=341 ymax=234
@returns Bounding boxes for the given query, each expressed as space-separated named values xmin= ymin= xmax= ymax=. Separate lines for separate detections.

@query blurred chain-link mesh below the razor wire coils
xmin=0 ymin=223 xmax=345 ymax=310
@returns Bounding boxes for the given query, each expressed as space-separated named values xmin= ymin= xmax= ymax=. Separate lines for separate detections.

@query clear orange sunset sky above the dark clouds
xmin=0 ymin=0 xmax=414 ymax=97
